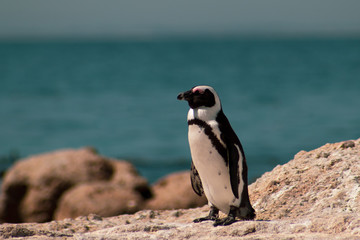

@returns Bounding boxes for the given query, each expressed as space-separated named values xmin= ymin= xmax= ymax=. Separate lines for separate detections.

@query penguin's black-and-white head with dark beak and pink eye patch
xmin=177 ymin=86 xmax=221 ymax=110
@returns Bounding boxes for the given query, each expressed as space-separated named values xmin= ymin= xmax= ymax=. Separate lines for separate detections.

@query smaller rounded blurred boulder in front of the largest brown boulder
xmin=54 ymin=182 xmax=144 ymax=220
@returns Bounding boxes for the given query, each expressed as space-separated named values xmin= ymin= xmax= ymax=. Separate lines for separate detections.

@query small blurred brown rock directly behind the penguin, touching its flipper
xmin=145 ymin=171 xmax=207 ymax=210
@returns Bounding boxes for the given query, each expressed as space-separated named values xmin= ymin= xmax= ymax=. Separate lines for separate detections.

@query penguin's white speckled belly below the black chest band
xmin=188 ymin=124 xmax=240 ymax=214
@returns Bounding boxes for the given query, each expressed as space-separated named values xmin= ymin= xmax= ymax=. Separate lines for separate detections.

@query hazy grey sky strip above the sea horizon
xmin=0 ymin=0 xmax=360 ymax=39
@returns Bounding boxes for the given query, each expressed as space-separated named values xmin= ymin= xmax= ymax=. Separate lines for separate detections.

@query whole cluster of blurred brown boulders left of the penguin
xmin=0 ymin=148 xmax=207 ymax=223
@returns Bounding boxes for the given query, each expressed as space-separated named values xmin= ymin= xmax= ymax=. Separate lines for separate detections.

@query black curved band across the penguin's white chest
xmin=188 ymin=118 xmax=228 ymax=166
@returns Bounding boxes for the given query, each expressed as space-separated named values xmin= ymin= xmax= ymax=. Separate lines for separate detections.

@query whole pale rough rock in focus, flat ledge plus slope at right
xmin=0 ymin=139 xmax=360 ymax=239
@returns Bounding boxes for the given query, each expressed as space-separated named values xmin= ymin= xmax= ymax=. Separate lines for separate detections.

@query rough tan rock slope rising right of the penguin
xmin=249 ymin=140 xmax=360 ymax=222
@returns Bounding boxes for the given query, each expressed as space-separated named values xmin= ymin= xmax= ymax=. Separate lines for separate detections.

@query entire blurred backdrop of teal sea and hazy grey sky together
xmin=0 ymin=0 xmax=360 ymax=182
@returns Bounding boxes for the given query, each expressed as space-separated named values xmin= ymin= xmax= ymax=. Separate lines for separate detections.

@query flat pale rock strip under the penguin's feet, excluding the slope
xmin=0 ymin=206 xmax=360 ymax=240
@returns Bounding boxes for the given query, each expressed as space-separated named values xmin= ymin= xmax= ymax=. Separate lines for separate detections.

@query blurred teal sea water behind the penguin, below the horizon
xmin=0 ymin=38 xmax=360 ymax=182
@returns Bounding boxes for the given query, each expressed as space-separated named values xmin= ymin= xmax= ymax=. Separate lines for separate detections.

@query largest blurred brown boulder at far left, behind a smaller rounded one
xmin=0 ymin=148 xmax=151 ymax=222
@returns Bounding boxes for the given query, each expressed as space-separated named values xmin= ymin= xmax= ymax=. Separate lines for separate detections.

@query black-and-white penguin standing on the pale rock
xmin=177 ymin=86 xmax=255 ymax=226
